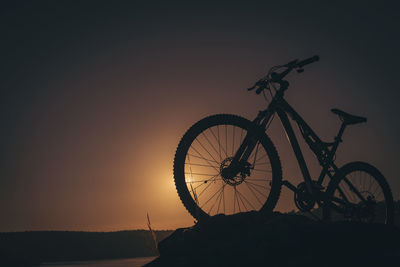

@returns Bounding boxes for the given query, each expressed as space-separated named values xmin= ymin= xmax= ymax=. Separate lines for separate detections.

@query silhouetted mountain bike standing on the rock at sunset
xmin=174 ymin=56 xmax=394 ymax=224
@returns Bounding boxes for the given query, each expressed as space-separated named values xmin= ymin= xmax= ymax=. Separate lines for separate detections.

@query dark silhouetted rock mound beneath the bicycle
xmin=146 ymin=212 xmax=400 ymax=267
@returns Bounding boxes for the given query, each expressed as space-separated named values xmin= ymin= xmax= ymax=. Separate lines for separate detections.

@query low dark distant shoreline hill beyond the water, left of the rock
xmin=0 ymin=230 xmax=172 ymax=266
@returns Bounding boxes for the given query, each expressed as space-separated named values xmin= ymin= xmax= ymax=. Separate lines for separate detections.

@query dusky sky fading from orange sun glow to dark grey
xmin=0 ymin=1 xmax=400 ymax=231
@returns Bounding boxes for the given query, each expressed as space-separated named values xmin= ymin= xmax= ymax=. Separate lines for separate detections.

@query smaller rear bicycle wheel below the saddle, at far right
xmin=324 ymin=162 xmax=394 ymax=224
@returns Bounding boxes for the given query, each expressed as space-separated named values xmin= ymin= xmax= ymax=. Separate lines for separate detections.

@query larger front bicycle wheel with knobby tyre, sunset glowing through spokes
xmin=174 ymin=114 xmax=282 ymax=220
